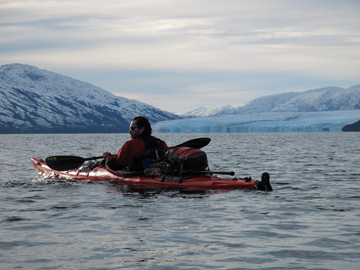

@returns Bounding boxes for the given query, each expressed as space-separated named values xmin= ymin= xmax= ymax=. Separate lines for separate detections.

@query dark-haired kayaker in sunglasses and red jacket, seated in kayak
xmin=103 ymin=116 xmax=169 ymax=171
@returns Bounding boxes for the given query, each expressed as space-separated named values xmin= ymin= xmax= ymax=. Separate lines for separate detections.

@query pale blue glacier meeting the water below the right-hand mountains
xmin=153 ymin=110 xmax=360 ymax=133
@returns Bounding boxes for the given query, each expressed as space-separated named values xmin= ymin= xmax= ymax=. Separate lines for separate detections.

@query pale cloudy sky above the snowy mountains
xmin=0 ymin=0 xmax=360 ymax=113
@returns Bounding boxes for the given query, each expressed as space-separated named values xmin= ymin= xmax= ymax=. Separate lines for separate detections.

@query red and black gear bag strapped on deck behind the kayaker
xmin=166 ymin=147 xmax=208 ymax=175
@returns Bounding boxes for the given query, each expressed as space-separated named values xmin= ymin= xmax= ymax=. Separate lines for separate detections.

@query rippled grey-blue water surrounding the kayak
xmin=0 ymin=133 xmax=360 ymax=270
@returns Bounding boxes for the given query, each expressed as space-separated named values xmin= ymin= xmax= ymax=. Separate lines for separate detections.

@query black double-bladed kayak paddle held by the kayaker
xmin=45 ymin=138 xmax=211 ymax=171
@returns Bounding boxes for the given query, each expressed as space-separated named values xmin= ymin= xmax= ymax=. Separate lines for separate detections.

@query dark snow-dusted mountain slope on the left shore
xmin=0 ymin=64 xmax=179 ymax=133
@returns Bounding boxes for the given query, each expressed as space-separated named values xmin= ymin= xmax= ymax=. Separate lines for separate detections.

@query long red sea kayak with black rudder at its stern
xmin=31 ymin=158 xmax=272 ymax=191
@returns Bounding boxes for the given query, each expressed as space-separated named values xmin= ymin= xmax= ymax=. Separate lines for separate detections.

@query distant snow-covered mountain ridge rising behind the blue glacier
xmin=183 ymin=85 xmax=360 ymax=117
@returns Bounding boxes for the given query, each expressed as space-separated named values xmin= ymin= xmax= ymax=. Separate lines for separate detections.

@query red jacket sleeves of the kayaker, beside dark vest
xmin=106 ymin=139 xmax=170 ymax=168
